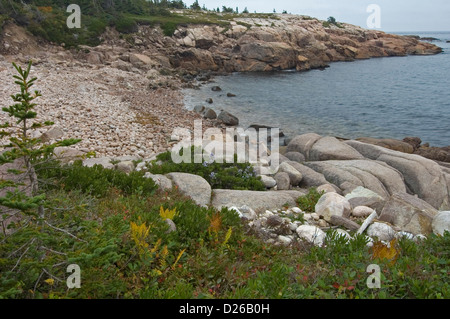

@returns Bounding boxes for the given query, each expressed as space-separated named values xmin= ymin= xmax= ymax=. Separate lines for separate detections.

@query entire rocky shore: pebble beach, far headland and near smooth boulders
xmin=0 ymin=15 xmax=450 ymax=245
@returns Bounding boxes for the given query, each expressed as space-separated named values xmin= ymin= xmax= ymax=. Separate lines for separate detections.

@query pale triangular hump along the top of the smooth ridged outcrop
xmin=310 ymin=136 xmax=364 ymax=161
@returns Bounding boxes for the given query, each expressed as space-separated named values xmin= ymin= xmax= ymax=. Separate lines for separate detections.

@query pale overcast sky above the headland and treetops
xmin=190 ymin=0 xmax=450 ymax=32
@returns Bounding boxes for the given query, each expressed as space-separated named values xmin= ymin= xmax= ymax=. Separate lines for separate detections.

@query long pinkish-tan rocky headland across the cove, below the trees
xmin=20 ymin=12 xmax=436 ymax=77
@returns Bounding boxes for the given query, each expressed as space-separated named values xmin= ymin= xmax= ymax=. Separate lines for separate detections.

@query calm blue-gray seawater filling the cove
xmin=184 ymin=32 xmax=450 ymax=146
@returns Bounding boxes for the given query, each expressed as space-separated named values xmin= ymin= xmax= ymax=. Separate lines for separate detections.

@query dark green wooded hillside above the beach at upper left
xmin=0 ymin=0 xmax=279 ymax=48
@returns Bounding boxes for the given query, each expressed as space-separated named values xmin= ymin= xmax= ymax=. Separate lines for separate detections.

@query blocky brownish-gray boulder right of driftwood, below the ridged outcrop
xmin=379 ymin=193 xmax=438 ymax=235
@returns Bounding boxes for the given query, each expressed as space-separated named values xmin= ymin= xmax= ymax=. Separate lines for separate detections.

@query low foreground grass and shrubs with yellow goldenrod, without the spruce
xmin=0 ymin=162 xmax=450 ymax=299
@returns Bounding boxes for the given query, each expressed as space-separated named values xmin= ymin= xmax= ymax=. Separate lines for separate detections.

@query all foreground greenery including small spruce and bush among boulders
xmin=0 ymin=63 xmax=450 ymax=299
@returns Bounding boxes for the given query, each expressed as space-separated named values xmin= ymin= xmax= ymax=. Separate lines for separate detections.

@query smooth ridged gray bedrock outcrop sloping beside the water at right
xmin=286 ymin=133 xmax=450 ymax=210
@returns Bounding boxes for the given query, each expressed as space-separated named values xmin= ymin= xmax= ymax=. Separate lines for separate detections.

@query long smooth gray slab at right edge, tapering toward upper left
xmin=345 ymin=141 xmax=450 ymax=210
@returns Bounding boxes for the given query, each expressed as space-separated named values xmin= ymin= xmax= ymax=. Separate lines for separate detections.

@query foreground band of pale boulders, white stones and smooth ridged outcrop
xmin=47 ymin=133 xmax=450 ymax=246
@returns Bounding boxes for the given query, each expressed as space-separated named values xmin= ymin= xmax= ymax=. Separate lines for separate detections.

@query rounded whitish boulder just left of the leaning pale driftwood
xmin=315 ymin=193 xmax=352 ymax=222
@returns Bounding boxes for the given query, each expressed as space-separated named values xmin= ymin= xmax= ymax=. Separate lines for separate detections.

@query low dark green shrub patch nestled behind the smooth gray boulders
xmin=147 ymin=147 xmax=266 ymax=191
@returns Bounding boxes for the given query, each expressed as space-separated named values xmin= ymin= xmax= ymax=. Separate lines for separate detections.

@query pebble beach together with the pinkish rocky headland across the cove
xmin=0 ymin=15 xmax=446 ymax=161
